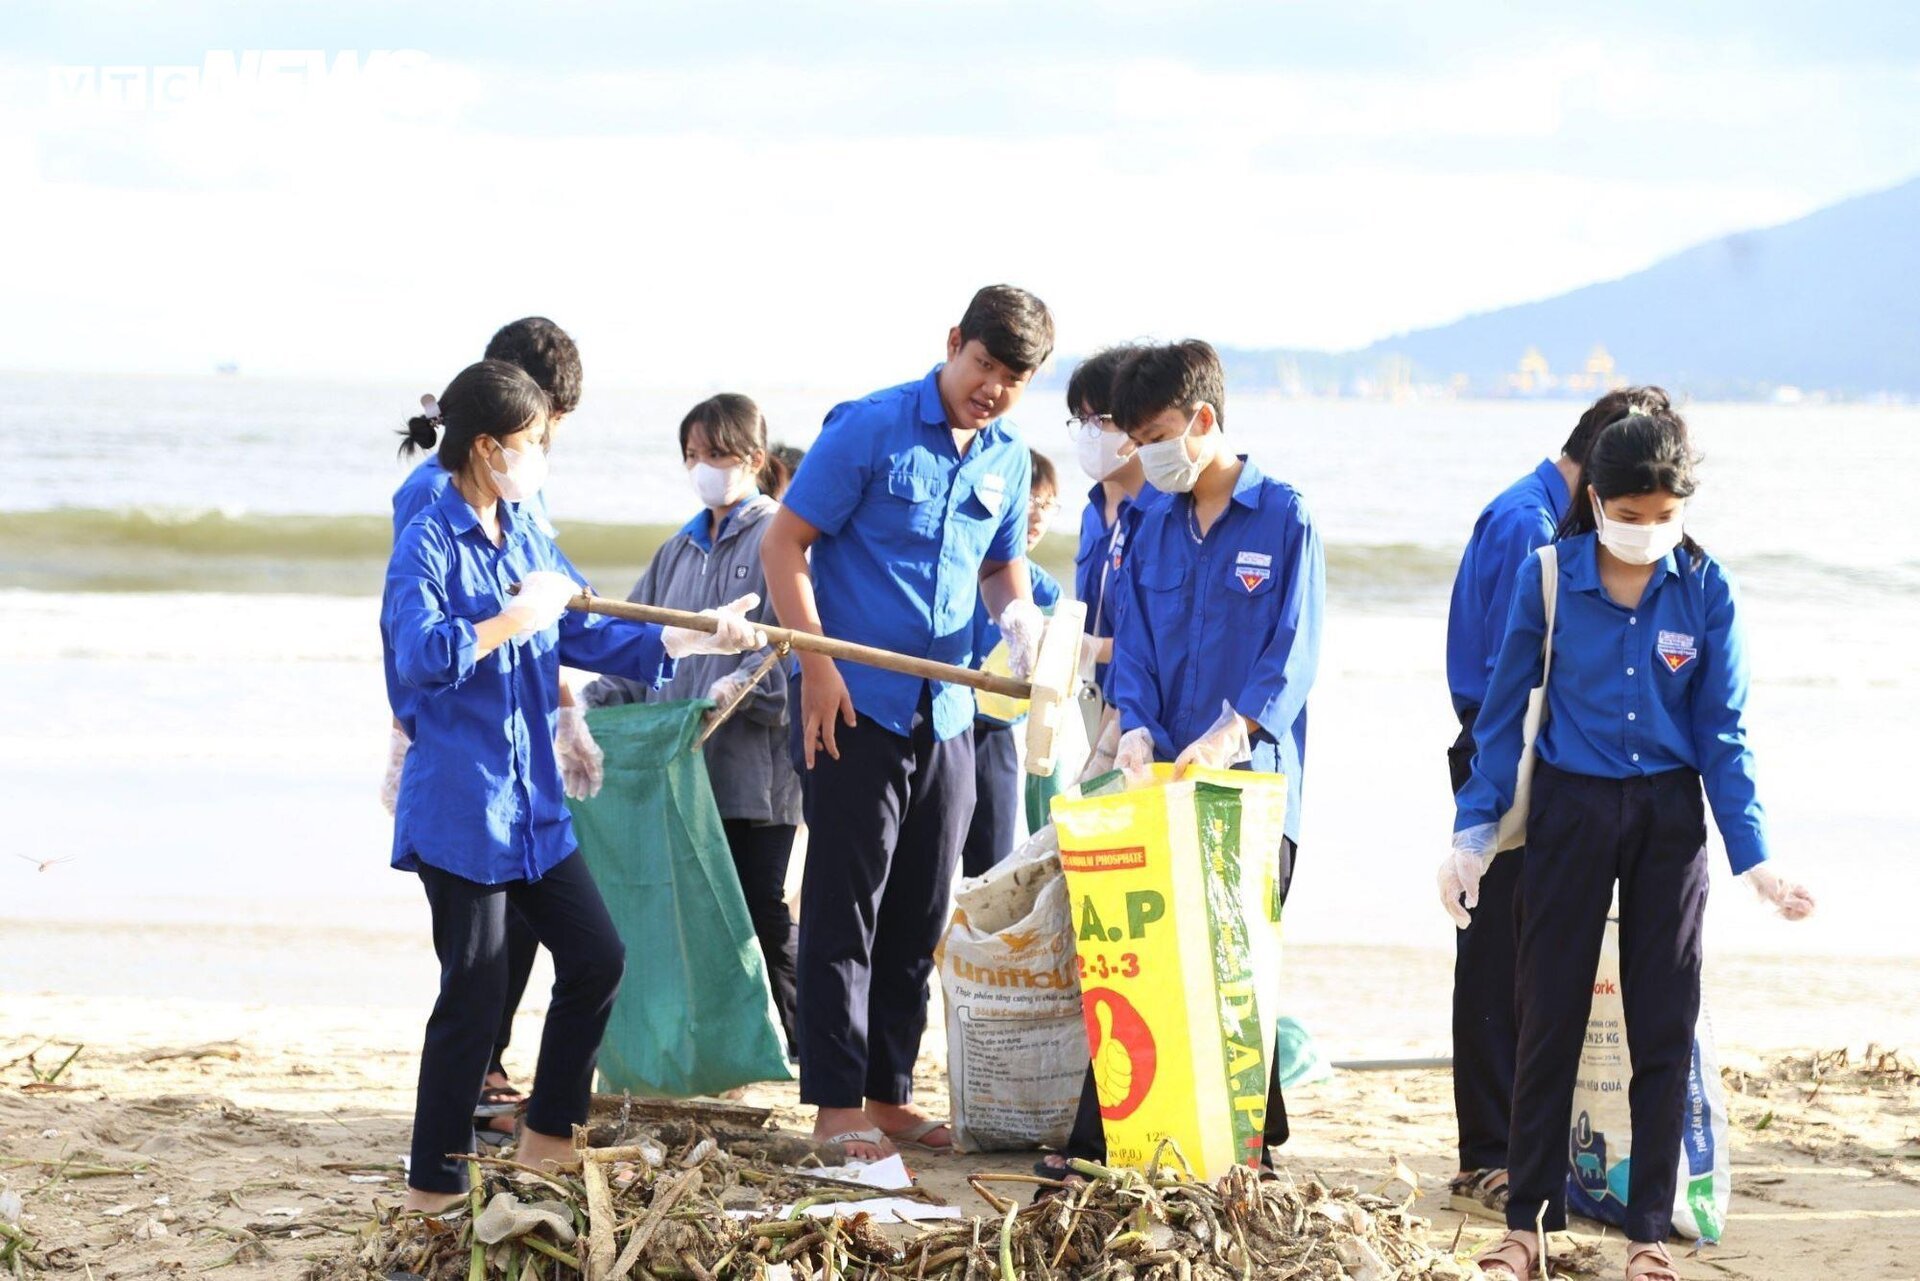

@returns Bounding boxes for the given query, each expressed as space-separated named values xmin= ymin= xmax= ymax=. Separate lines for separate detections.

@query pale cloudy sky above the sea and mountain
xmin=0 ymin=0 xmax=1920 ymax=390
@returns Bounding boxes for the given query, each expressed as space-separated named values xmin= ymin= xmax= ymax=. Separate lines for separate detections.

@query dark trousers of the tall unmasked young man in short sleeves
xmin=799 ymin=693 xmax=973 ymax=1108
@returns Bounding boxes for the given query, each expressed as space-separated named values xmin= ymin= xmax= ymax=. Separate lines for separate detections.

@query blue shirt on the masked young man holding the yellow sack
xmin=1108 ymin=463 xmax=1327 ymax=841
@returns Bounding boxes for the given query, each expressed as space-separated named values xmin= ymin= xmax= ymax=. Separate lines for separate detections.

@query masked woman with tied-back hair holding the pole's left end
xmin=380 ymin=361 xmax=764 ymax=1212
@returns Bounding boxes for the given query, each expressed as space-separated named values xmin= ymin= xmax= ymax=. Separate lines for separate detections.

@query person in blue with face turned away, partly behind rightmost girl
xmin=1446 ymin=388 xmax=1668 ymax=1214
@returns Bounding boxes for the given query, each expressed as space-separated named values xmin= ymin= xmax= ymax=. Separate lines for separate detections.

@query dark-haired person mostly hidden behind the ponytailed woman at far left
xmin=380 ymin=315 xmax=579 ymax=1135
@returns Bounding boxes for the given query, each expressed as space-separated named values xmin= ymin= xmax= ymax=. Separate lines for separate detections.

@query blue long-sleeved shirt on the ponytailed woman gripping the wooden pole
xmin=380 ymin=486 xmax=674 ymax=885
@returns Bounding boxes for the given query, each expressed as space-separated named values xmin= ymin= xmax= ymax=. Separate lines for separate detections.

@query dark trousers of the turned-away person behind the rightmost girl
xmin=1446 ymin=707 xmax=1526 ymax=1170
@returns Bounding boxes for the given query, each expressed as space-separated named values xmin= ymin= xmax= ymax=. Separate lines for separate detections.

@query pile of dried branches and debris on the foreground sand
xmin=309 ymin=1131 xmax=1478 ymax=1281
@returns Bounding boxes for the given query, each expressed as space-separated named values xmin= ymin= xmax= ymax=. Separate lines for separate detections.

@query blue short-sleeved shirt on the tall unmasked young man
xmin=781 ymin=365 xmax=1033 ymax=739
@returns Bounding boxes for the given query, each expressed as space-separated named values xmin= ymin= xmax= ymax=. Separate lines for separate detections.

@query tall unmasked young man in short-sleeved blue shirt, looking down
xmin=760 ymin=284 xmax=1054 ymax=1160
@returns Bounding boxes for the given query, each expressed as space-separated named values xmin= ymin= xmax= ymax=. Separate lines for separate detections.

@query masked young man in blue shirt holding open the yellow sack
xmin=1068 ymin=340 xmax=1327 ymax=1158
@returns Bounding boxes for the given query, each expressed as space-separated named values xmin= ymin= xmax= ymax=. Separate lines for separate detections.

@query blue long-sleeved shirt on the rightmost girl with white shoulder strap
xmin=1453 ymin=534 xmax=1766 ymax=872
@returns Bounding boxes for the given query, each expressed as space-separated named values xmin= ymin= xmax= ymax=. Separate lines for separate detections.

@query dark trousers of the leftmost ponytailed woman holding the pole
xmin=407 ymin=853 xmax=626 ymax=1193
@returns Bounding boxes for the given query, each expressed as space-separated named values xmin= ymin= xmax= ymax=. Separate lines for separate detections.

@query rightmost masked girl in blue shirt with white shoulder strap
xmin=1440 ymin=409 xmax=1812 ymax=1281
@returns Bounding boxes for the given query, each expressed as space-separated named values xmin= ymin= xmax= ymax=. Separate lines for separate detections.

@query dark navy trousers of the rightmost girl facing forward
xmin=1507 ymin=764 xmax=1707 ymax=1241
